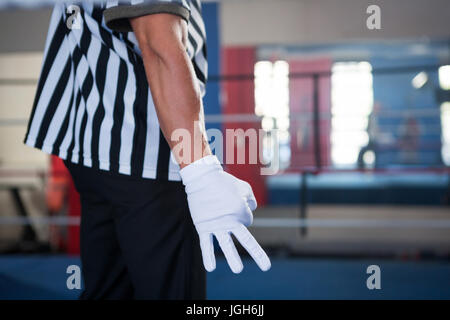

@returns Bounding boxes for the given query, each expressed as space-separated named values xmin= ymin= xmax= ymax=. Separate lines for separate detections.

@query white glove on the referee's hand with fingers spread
xmin=180 ymin=156 xmax=270 ymax=273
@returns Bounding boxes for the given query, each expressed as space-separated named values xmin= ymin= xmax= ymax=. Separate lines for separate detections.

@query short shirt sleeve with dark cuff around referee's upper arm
xmin=103 ymin=0 xmax=190 ymax=32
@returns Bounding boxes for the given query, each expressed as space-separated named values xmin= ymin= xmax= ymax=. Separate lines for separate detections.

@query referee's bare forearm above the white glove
xmin=130 ymin=14 xmax=211 ymax=168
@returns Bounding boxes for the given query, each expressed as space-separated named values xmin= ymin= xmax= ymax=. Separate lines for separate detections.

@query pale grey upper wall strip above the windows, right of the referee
xmin=220 ymin=0 xmax=450 ymax=45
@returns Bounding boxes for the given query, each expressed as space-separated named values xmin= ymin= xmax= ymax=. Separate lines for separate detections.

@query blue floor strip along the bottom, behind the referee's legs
xmin=0 ymin=255 xmax=450 ymax=299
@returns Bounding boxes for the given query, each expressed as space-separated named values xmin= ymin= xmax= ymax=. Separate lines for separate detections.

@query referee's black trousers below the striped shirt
xmin=64 ymin=161 xmax=206 ymax=299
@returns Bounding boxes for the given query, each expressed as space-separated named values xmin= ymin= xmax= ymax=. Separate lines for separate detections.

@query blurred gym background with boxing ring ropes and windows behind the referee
xmin=0 ymin=0 xmax=450 ymax=299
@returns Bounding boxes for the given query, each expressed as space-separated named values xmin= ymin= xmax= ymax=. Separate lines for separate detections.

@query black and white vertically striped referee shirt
xmin=25 ymin=0 xmax=207 ymax=180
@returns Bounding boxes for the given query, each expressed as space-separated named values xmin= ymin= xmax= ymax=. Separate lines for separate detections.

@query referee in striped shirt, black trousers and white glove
xmin=25 ymin=0 xmax=270 ymax=299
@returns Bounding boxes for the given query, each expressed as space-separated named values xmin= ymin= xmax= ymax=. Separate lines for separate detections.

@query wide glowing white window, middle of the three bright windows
xmin=331 ymin=62 xmax=373 ymax=167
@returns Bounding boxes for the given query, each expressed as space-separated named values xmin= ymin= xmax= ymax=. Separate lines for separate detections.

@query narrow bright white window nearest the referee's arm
xmin=254 ymin=60 xmax=290 ymax=168
